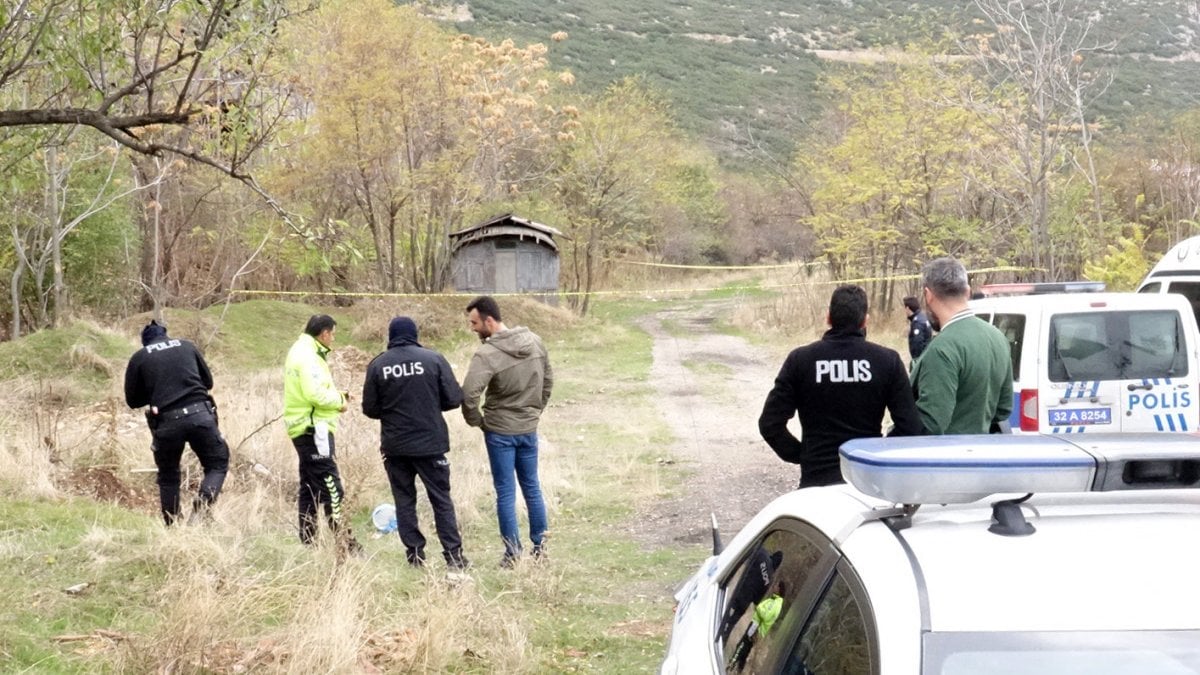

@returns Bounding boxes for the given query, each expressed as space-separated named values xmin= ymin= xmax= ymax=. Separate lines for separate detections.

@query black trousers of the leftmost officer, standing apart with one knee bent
xmin=150 ymin=410 xmax=229 ymax=525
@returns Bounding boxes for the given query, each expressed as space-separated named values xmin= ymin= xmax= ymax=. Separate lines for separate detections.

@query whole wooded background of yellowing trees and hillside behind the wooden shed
xmin=0 ymin=0 xmax=1200 ymax=338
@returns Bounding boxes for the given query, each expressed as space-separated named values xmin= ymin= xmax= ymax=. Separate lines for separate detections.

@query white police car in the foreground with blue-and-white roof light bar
xmin=661 ymin=434 xmax=1200 ymax=675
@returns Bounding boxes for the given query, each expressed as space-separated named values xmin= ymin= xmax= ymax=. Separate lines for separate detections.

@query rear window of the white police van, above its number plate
xmin=1048 ymin=310 xmax=1188 ymax=382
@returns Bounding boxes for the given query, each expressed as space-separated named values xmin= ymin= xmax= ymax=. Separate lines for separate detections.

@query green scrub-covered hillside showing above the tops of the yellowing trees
xmin=446 ymin=0 xmax=1200 ymax=162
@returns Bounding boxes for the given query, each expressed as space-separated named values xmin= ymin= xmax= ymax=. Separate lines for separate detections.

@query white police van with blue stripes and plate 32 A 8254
xmin=971 ymin=283 xmax=1200 ymax=434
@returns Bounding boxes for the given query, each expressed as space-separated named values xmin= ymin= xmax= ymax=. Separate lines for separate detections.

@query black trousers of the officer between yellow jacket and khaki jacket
xmin=383 ymin=455 xmax=464 ymax=565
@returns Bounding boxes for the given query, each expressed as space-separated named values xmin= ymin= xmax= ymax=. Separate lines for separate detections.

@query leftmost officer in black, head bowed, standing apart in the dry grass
xmin=125 ymin=321 xmax=229 ymax=525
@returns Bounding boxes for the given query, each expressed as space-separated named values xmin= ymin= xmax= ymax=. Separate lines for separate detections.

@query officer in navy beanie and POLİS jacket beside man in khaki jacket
xmin=362 ymin=316 xmax=468 ymax=569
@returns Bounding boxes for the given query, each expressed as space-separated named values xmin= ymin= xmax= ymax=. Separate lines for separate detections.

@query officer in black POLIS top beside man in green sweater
xmin=758 ymin=285 xmax=923 ymax=488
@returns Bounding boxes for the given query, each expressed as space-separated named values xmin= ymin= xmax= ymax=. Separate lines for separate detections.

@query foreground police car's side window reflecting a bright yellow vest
xmin=716 ymin=526 xmax=835 ymax=673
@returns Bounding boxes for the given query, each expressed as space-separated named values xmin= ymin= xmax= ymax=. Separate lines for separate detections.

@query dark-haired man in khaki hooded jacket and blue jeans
xmin=462 ymin=295 xmax=553 ymax=567
